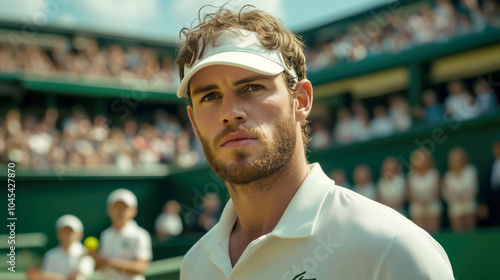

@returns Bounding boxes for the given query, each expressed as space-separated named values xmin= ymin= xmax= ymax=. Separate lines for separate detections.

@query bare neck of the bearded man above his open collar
xmin=227 ymin=150 xmax=309 ymax=247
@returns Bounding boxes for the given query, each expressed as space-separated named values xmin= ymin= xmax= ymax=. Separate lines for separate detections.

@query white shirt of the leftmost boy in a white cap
xmin=42 ymin=242 xmax=95 ymax=279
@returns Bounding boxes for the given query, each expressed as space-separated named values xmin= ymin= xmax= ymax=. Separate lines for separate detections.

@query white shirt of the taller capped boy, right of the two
xmin=100 ymin=220 xmax=153 ymax=280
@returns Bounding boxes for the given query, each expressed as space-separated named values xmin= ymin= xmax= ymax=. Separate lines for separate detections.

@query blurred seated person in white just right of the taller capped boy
xmin=155 ymin=200 xmax=183 ymax=241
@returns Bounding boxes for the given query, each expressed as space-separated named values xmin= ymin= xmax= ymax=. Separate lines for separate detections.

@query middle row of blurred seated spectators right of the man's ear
xmin=311 ymin=79 xmax=498 ymax=149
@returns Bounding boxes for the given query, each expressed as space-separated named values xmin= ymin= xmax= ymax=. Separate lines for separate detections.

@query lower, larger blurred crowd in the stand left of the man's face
xmin=0 ymin=106 xmax=204 ymax=170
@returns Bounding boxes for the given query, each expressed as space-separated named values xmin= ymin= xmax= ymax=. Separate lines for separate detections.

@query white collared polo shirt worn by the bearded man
xmin=180 ymin=163 xmax=454 ymax=280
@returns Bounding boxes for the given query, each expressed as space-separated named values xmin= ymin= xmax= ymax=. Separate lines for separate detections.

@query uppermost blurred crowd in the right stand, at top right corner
xmin=307 ymin=0 xmax=500 ymax=71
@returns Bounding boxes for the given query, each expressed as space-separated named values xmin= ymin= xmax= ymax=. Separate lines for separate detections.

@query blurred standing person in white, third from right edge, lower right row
xmin=408 ymin=149 xmax=442 ymax=232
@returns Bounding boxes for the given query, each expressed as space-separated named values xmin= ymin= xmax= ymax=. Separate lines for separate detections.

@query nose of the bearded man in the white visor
xmin=220 ymin=92 xmax=247 ymax=126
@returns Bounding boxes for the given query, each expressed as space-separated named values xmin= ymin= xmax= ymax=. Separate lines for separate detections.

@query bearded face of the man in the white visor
xmin=188 ymin=65 xmax=300 ymax=184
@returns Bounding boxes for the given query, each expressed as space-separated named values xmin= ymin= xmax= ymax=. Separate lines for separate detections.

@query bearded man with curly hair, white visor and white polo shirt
xmin=176 ymin=6 xmax=453 ymax=280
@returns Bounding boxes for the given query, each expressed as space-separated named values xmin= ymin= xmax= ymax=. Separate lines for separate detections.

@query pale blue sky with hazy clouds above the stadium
xmin=0 ymin=0 xmax=394 ymax=40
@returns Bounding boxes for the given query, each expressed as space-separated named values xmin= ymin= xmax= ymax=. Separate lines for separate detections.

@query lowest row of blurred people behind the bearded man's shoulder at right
xmin=331 ymin=140 xmax=500 ymax=232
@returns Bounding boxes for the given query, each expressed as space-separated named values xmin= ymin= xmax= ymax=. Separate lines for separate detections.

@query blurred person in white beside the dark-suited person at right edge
xmin=443 ymin=148 xmax=478 ymax=232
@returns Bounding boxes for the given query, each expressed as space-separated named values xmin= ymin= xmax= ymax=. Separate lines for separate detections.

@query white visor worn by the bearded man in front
xmin=177 ymin=28 xmax=297 ymax=98
